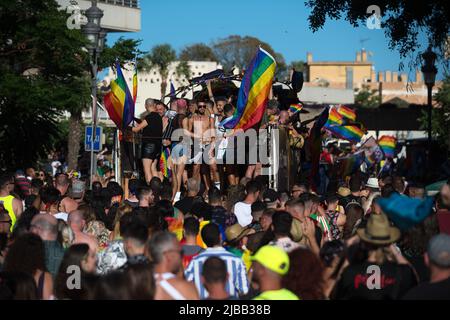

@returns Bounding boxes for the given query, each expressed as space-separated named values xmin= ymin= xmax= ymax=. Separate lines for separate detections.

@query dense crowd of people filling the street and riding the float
xmin=0 ymin=92 xmax=450 ymax=300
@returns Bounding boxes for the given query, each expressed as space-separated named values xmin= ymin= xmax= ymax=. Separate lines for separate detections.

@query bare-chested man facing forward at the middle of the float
xmin=189 ymin=101 xmax=215 ymax=190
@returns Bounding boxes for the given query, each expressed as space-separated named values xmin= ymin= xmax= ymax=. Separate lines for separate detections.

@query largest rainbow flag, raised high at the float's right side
xmin=223 ymin=48 xmax=276 ymax=131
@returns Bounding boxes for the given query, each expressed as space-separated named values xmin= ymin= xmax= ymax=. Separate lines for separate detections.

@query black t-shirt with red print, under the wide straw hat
xmin=332 ymin=262 xmax=417 ymax=300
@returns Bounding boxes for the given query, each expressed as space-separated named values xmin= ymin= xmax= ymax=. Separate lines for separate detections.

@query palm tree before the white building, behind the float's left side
xmin=138 ymin=44 xmax=177 ymax=98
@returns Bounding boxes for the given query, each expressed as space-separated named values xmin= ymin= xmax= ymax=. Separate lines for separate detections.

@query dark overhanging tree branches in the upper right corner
xmin=306 ymin=0 xmax=450 ymax=57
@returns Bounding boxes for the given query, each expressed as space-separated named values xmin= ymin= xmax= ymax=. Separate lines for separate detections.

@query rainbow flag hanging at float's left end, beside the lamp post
xmin=103 ymin=61 xmax=137 ymax=130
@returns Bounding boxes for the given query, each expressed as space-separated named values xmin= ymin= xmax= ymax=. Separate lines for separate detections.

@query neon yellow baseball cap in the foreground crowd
xmin=250 ymin=246 xmax=289 ymax=276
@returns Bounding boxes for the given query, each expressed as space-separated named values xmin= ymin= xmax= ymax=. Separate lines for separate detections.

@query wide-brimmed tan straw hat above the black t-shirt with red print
xmin=356 ymin=213 xmax=400 ymax=245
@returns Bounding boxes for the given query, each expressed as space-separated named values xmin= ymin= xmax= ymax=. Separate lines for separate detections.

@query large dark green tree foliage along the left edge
xmin=0 ymin=0 xmax=89 ymax=169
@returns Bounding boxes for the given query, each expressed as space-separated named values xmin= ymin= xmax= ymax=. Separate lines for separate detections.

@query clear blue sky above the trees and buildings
xmin=108 ymin=0 xmax=443 ymax=79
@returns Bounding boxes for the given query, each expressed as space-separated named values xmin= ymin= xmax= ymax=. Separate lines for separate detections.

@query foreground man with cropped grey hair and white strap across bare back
xmin=147 ymin=231 xmax=199 ymax=300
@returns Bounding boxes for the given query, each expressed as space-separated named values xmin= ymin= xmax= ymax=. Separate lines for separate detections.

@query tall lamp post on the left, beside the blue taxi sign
xmin=81 ymin=0 xmax=106 ymax=189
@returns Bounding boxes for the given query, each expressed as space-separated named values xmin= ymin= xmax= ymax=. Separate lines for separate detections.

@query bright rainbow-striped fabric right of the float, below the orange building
xmin=324 ymin=107 xmax=364 ymax=143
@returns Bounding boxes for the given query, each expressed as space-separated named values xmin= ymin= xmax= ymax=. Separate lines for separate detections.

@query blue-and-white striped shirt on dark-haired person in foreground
xmin=184 ymin=247 xmax=248 ymax=299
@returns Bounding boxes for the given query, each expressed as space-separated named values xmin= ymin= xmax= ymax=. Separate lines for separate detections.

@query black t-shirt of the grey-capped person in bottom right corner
xmin=403 ymin=277 xmax=450 ymax=300
